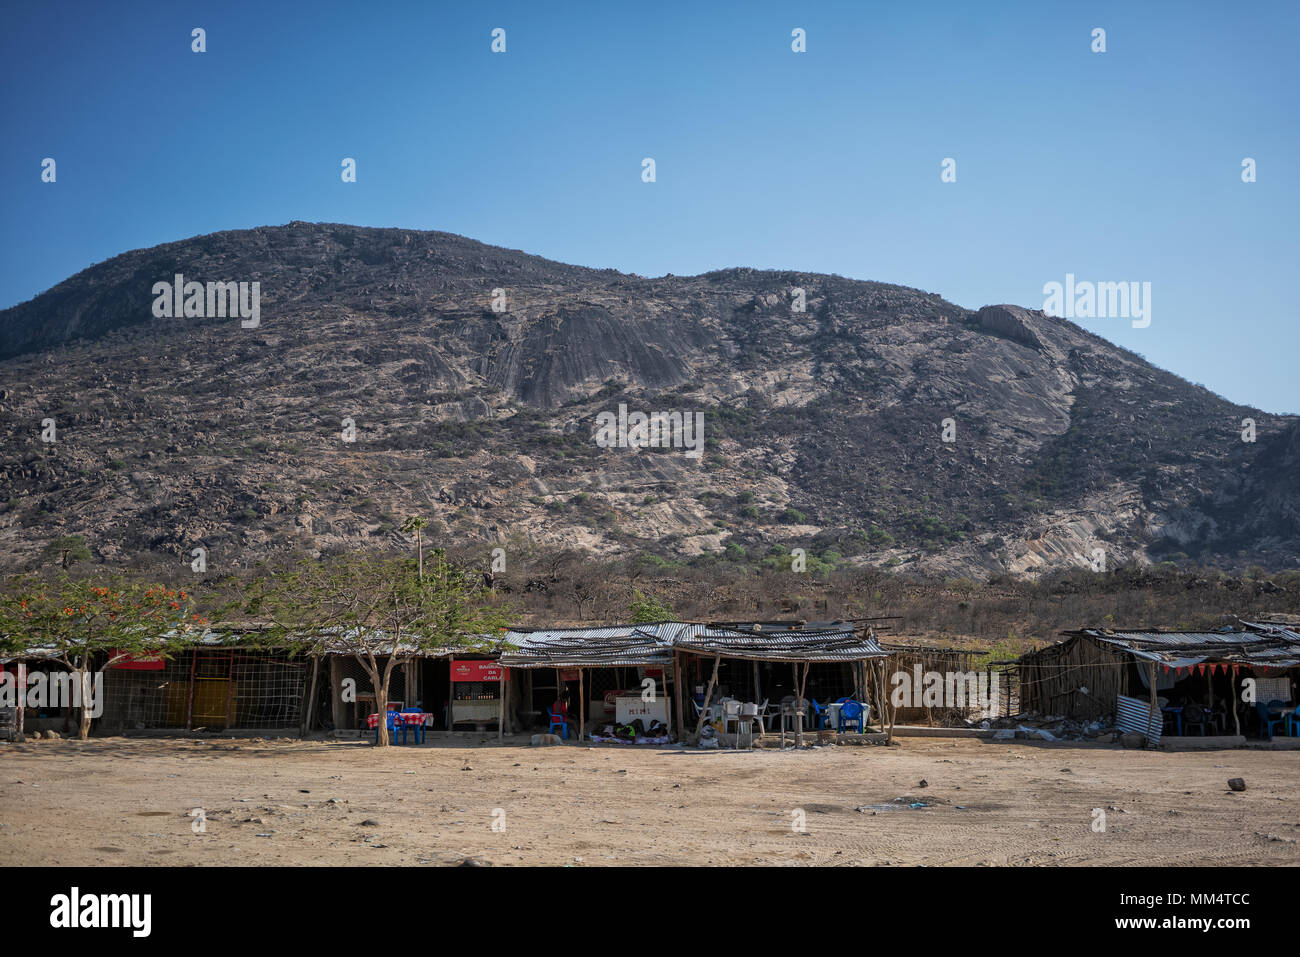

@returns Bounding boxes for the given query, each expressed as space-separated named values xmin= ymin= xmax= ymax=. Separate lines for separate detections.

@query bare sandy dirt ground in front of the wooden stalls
xmin=0 ymin=739 xmax=1300 ymax=866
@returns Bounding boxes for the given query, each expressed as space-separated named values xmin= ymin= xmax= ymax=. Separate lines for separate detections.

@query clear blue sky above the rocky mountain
xmin=0 ymin=0 xmax=1300 ymax=412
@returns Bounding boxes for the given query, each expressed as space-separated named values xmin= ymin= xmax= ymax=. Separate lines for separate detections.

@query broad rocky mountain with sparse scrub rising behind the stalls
xmin=0 ymin=222 xmax=1300 ymax=577
